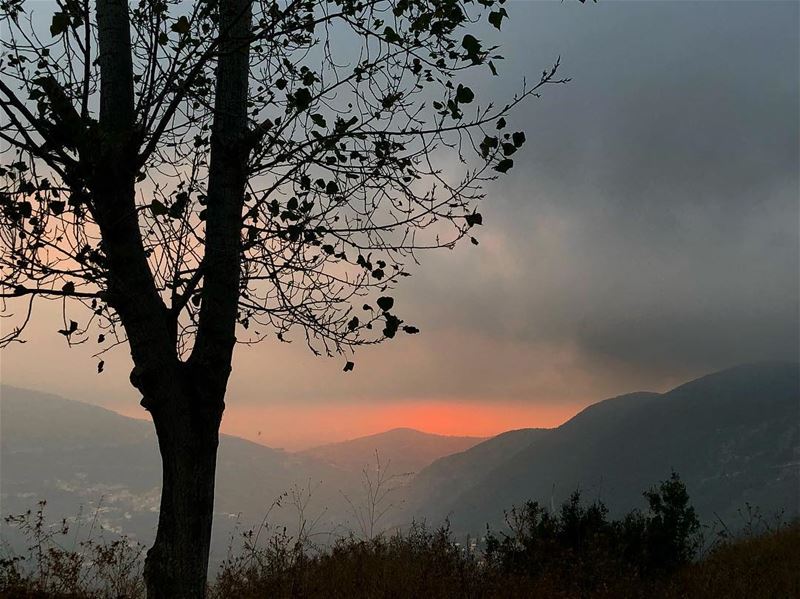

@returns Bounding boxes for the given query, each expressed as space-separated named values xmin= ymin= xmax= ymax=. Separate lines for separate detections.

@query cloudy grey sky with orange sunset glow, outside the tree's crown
xmin=0 ymin=0 xmax=800 ymax=449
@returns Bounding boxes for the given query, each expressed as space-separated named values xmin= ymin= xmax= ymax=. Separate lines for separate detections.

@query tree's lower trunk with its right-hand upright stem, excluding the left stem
xmin=145 ymin=0 xmax=251 ymax=599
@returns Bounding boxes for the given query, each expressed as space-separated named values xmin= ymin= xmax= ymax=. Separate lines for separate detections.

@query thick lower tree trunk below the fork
xmin=144 ymin=367 xmax=224 ymax=599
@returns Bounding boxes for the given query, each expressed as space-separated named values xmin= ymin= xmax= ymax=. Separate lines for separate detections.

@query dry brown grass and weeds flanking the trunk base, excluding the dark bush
xmin=0 ymin=510 xmax=800 ymax=599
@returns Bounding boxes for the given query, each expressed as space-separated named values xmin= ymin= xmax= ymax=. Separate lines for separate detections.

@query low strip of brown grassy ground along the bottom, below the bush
xmin=0 ymin=524 xmax=800 ymax=599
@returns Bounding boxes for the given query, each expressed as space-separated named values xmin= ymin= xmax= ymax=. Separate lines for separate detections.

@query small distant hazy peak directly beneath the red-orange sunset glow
xmin=301 ymin=428 xmax=485 ymax=474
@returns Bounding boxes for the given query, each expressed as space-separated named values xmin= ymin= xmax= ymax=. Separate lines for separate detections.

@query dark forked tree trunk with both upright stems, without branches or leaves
xmin=95 ymin=0 xmax=252 ymax=599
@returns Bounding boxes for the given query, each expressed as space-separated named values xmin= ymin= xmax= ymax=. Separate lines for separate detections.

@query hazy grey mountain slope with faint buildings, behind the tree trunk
xmin=0 ymin=385 xmax=361 ymax=559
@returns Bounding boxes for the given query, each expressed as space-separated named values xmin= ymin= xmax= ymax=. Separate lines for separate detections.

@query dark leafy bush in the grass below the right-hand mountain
xmin=486 ymin=473 xmax=700 ymax=590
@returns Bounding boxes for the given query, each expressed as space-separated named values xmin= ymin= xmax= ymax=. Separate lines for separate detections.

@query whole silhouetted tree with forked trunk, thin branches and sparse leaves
xmin=0 ymin=0 xmax=564 ymax=597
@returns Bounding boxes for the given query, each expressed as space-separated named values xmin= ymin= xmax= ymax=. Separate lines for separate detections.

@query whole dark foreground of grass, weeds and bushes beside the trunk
xmin=0 ymin=474 xmax=800 ymax=599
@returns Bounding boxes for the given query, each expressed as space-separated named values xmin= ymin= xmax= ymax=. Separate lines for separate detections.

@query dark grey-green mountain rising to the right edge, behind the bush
xmin=405 ymin=363 xmax=800 ymax=534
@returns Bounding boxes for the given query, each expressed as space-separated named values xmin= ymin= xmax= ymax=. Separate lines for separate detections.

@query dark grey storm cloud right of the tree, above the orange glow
xmin=409 ymin=2 xmax=799 ymax=374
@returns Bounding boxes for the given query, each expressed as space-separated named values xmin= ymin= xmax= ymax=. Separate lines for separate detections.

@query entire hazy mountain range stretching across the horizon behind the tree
xmin=0 ymin=363 xmax=800 ymax=563
